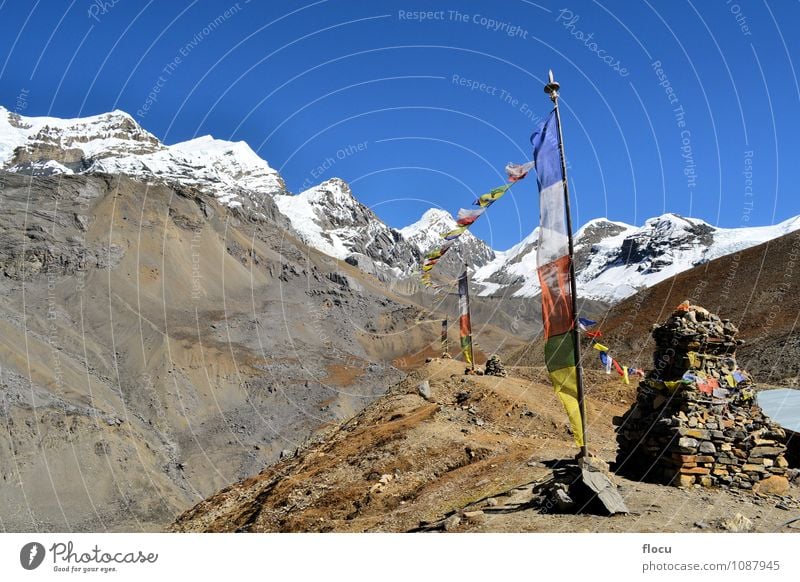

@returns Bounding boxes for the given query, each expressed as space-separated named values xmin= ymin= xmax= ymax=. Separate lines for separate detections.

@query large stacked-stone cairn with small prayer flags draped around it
xmin=614 ymin=301 xmax=788 ymax=492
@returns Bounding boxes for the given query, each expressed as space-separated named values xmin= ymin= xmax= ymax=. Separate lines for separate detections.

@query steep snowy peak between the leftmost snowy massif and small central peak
xmin=274 ymin=178 xmax=420 ymax=278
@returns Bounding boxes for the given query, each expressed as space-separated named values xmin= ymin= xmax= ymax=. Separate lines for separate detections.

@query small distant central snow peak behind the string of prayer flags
xmin=400 ymin=208 xmax=495 ymax=276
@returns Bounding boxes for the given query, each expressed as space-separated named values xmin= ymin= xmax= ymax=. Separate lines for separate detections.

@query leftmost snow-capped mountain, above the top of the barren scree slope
xmin=0 ymin=107 xmax=286 ymax=207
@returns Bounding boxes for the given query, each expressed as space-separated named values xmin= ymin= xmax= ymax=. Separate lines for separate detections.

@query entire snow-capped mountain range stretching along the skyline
xmin=6 ymin=107 xmax=800 ymax=304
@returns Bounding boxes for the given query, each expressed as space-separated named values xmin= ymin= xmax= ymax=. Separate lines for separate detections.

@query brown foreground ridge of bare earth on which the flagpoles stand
xmin=170 ymin=360 xmax=798 ymax=533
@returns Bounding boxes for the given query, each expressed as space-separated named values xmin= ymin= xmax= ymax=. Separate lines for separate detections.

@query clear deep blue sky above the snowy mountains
xmin=0 ymin=0 xmax=800 ymax=249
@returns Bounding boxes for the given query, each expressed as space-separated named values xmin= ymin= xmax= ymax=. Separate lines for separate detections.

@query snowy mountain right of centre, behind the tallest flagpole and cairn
xmin=474 ymin=214 xmax=800 ymax=303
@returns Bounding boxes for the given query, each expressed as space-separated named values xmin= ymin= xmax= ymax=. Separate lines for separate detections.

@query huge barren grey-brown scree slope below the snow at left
xmin=0 ymin=172 xmax=532 ymax=531
